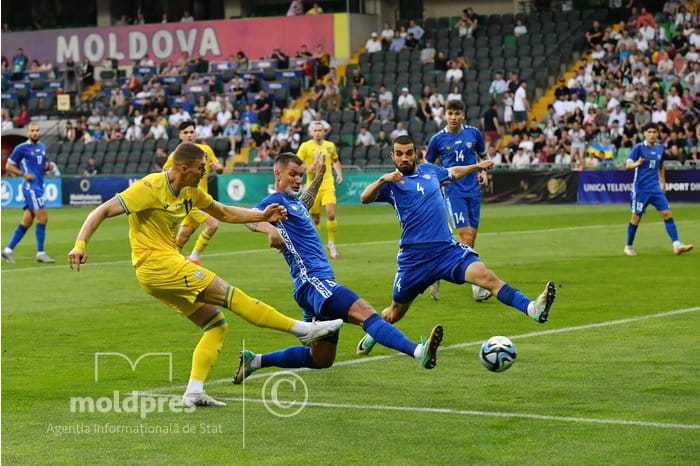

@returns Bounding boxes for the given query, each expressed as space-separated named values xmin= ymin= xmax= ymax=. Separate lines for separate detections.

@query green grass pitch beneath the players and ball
xmin=2 ymin=204 xmax=700 ymax=465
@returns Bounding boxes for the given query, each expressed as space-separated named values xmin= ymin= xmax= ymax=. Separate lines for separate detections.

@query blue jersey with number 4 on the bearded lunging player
xmin=372 ymin=163 xmax=454 ymax=247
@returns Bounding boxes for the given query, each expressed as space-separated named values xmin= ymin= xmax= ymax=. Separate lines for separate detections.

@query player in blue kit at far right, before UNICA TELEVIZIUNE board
xmin=624 ymin=123 xmax=693 ymax=256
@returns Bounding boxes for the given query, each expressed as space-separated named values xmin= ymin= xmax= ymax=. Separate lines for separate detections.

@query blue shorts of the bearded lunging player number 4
xmin=392 ymin=241 xmax=480 ymax=304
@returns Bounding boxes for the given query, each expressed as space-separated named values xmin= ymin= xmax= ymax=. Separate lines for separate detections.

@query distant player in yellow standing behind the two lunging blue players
xmin=297 ymin=121 xmax=343 ymax=259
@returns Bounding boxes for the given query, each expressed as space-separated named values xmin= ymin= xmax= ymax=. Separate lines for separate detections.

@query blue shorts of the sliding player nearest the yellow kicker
xmin=294 ymin=277 xmax=360 ymax=344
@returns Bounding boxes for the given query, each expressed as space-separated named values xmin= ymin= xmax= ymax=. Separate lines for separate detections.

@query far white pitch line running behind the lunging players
xmin=2 ymin=220 xmax=693 ymax=273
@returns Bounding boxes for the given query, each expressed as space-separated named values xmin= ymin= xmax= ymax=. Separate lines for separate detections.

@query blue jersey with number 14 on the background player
xmin=425 ymin=125 xmax=486 ymax=196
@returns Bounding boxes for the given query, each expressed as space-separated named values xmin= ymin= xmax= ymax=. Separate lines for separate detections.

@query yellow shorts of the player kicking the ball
xmin=136 ymin=254 xmax=216 ymax=317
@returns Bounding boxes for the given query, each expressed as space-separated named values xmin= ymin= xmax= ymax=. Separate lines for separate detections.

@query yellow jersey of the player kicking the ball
xmin=117 ymin=172 xmax=214 ymax=268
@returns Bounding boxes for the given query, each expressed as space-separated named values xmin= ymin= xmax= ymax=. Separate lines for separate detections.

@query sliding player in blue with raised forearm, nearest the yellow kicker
xmin=233 ymin=152 xmax=443 ymax=384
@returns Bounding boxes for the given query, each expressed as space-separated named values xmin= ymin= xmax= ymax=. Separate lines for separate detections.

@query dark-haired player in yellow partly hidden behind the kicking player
xmin=163 ymin=120 xmax=224 ymax=264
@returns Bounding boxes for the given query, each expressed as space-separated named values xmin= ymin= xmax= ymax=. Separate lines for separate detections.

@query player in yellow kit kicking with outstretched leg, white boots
xmin=68 ymin=142 xmax=342 ymax=407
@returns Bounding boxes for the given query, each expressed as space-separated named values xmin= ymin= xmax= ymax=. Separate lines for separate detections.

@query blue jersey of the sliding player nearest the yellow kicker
xmin=255 ymin=192 xmax=335 ymax=289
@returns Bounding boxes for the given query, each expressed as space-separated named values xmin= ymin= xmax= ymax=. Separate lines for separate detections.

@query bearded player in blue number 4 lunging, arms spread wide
xmin=357 ymin=136 xmax=556 ymax=354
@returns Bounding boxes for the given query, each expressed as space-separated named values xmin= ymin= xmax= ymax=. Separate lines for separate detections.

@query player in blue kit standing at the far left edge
xmin=2 ymin=123 xmax=56 ymax=264
